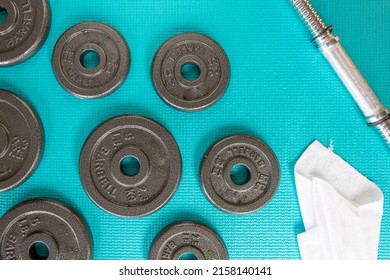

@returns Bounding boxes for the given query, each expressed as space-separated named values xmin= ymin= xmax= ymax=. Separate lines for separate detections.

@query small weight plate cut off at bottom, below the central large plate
xmin=149 ymin=223 xmax=228 ymax=260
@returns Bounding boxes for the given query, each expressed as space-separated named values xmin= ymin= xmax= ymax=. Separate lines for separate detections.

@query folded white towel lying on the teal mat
xmin=295 ymin=141 xmax=383 ymax=260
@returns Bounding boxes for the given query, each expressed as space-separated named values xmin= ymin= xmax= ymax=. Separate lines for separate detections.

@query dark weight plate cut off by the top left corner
xmin=0 ymin=0 xmax=50 ymax=67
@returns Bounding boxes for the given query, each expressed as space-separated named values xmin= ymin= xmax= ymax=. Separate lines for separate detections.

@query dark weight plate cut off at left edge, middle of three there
xmin=0 ymin=90 xmax=43 ymax=192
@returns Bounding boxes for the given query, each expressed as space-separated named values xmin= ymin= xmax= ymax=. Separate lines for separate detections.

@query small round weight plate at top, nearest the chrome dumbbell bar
xmin=152 ymin=33 xmax=230 ymax=112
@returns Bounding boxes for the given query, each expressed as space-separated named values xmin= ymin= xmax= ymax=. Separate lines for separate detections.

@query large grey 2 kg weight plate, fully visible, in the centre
xmin=80 ymin=116 xmax=182 ymax=218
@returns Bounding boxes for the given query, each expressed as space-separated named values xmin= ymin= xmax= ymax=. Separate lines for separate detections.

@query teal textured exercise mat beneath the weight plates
xmin=0 ymin=0 xmax=390 ymax=259
